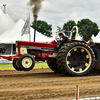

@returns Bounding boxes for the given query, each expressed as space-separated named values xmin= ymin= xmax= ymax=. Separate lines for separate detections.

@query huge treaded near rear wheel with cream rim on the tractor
xmin=57 ymin=42 xmax=95 ymax=76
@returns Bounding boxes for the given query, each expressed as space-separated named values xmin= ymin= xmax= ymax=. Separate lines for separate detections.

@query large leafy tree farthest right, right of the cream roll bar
xmin=77 ymin=19 xmax=100 ymax=41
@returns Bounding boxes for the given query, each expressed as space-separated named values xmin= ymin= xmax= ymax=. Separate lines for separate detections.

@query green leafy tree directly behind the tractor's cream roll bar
xmin=63 ymin=20 xmax=76 ymax=39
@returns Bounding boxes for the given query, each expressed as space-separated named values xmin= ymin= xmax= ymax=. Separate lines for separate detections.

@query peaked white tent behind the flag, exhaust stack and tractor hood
xmin=0 ymin=19 xmax=54 ymax=44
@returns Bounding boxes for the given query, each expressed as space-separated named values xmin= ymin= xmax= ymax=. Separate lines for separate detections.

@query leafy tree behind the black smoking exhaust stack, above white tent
xmin=31 ymin=20 xmax=52 ymax=37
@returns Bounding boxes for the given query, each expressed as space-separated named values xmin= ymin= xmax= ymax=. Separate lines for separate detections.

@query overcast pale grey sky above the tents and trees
xmin=0 ymin=0 xmax=100 ymax=32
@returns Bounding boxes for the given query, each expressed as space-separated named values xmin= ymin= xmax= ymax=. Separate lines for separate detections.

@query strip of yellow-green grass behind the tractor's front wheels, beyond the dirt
xmin=0 ymin=62 xmax=49 ymax=70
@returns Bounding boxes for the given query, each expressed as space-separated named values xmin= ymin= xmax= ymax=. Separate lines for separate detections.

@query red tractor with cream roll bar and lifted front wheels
xmin=1 ymin=26 xmax=100 ymax=76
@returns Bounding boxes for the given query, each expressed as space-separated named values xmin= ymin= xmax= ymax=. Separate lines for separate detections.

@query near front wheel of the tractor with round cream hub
xmin=18 ymin=54 xmax=35 ymax=71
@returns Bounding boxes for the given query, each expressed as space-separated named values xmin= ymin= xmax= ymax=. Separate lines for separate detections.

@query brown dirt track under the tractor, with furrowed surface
xmin=0 ymin=69 xmax=100 ymax=100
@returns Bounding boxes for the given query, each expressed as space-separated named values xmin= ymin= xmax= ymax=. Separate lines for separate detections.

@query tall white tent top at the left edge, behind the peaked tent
xmin=0 ymin=9 xmax=15 ymax=34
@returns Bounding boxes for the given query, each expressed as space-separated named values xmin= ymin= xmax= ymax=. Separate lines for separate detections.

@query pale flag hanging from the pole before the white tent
xmin=21 ymin=17 xmax=30 ymax=36
